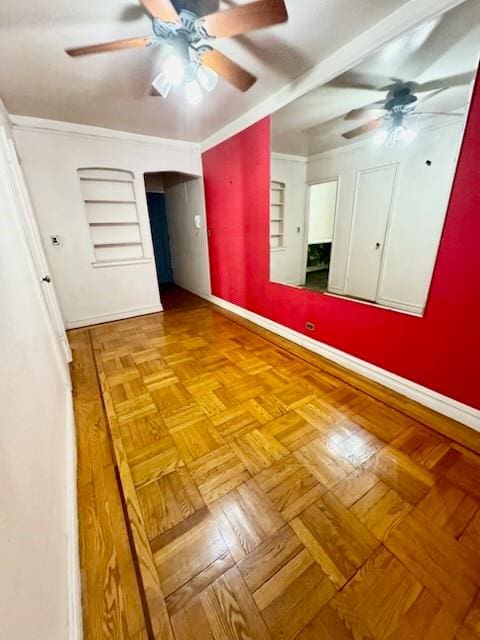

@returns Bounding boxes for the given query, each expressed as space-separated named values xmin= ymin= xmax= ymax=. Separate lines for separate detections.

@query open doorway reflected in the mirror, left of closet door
xmin=305 ymin=179 xmax=338 ymax=291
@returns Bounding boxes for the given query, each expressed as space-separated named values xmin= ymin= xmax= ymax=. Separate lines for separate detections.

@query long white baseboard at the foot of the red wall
xmin=193 ymin=292 xmax=480 ymax=431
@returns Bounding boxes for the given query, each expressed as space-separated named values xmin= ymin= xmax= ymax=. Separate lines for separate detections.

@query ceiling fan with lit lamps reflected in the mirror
xmin=337 ymin=72 xmax=474 ymax=147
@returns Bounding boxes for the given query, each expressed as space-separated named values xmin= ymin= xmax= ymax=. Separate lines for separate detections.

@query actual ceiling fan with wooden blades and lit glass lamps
xmin=66 ymin=0 xmax=288 ymax=104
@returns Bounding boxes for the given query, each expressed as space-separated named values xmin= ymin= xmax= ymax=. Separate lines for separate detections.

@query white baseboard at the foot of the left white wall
xmin=66 ymin=389 xmax=83 ymax=640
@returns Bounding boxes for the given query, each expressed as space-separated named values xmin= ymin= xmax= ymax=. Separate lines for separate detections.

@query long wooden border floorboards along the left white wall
xmin=69 ymin=329 xmax=147 ymax=640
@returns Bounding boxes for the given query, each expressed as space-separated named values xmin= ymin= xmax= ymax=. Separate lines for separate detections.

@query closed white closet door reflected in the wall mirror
xmin=347 ymin=164 xmax=397 ymax=302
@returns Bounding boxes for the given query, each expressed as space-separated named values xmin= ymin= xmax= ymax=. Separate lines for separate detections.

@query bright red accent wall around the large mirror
xmin=203 ymin=72 xmax=480 ymax=409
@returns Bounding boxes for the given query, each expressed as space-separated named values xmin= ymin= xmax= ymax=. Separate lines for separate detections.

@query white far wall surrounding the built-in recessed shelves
xmin=14 ymin=119 xmax=202 ymax=327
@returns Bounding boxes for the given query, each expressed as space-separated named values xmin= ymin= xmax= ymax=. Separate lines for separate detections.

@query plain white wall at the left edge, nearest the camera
xmin=0 ymin=113 xmax=75 ymax=640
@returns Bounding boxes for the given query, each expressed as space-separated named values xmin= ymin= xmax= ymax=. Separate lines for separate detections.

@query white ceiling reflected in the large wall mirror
xmin=272 ymin=0 xmax=480 ymax=156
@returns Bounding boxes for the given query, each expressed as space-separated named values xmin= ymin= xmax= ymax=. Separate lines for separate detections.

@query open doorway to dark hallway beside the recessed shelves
xmin=144 ymin=171 xmax=210 ymax=311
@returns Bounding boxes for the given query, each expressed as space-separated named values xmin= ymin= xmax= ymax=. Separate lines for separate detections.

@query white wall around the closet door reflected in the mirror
xmin=307 ymin=118 xmax=464 ymax=313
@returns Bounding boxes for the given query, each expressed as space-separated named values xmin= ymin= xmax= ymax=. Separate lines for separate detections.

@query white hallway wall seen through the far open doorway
xmin=163 ymin=175 xmax=211 ymax=294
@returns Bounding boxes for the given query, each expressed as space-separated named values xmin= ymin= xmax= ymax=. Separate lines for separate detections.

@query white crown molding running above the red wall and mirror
xmin=201 ymin=0 xmax=465 ymax=152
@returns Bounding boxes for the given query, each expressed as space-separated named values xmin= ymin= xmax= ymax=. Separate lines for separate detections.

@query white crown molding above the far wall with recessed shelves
xmin=9 ymin=114 xmax=200 ymax=152
